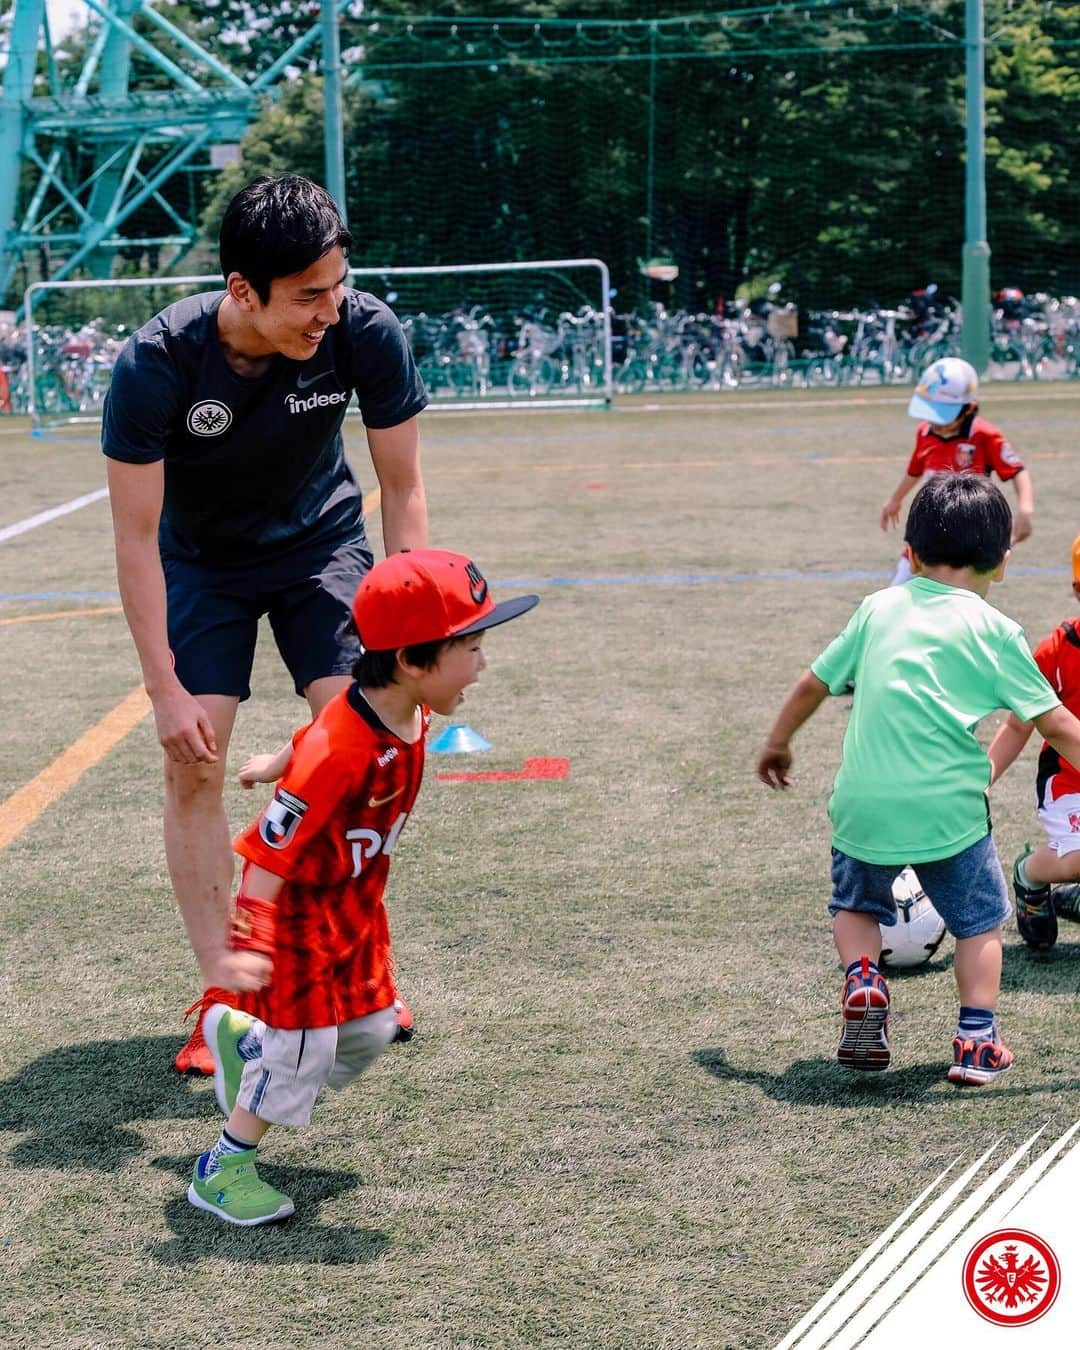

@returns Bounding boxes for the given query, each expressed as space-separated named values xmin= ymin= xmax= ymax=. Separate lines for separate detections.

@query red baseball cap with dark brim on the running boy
xmin=352 ymin=548 xmax=540 ymax=652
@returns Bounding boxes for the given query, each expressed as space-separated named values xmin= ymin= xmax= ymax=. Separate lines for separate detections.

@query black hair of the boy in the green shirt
xmin=903 ymin=474 xmax=1013 ymax=572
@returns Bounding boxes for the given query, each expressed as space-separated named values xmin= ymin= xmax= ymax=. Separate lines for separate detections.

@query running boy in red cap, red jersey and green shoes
xmin=188 ymin=548 xmax=537 ymax=1227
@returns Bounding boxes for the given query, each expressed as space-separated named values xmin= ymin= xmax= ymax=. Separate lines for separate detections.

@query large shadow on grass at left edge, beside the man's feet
xmin=0 ymin=1035 xmax=217 ymax=1172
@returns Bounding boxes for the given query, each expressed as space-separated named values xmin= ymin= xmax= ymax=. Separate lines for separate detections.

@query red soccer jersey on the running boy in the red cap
xmin=234 ymin=684 xmax=431 ymax=1030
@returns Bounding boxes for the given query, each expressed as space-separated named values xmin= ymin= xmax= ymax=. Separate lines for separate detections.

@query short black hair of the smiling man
xmin=220 ymin=173 xmax=352 ymax=304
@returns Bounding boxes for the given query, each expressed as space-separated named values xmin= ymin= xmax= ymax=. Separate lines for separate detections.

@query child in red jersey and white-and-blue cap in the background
xmin=882 ymin=356 xmax=1035 ymax=586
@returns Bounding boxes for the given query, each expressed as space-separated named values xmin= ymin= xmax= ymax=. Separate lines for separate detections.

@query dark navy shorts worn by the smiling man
xmin=162 ymin=539 xmax=373 ymax=699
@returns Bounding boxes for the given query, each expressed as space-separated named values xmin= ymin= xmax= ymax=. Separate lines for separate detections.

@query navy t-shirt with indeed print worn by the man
xmin=101 ymin=289 xmax=428 ymax=566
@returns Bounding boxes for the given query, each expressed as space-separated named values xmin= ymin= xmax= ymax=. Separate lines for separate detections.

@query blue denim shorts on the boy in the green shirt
xmin=829 ymin=834 xmax=1013 ymax=937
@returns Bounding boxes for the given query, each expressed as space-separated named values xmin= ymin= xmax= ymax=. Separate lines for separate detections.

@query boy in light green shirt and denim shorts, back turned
xmin=757 ymin=474 xmax=1080 ymax=1085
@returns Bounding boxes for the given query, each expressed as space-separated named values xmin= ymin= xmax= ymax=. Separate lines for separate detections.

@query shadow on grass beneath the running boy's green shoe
xmin=149 ymin=1158 xmax=390 ymax=1266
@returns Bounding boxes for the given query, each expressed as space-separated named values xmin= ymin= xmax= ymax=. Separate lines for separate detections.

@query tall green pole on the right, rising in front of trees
xmin=961 ymin=0 xmax=990 ymax=375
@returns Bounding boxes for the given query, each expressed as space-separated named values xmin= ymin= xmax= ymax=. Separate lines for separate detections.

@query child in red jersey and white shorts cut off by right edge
xmin=988 ymin=535 xmax=1080 ymax=952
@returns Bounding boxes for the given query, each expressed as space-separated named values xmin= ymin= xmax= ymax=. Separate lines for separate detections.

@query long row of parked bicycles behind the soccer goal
xmin=0 ymin=288 xmax=1080 ymax=413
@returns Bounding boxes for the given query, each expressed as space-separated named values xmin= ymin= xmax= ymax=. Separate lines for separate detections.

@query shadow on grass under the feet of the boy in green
xmin=691 ymin=1049 xmax=945 ymax=1107
